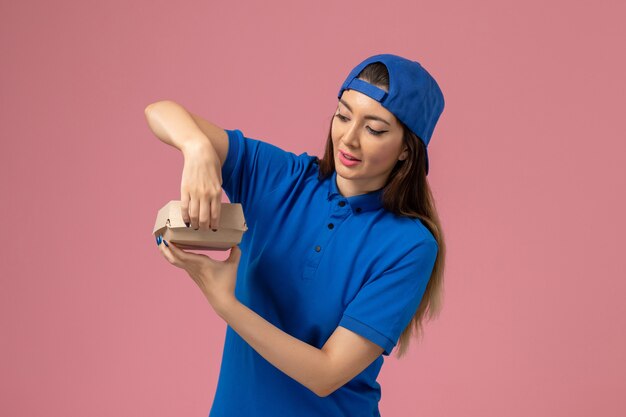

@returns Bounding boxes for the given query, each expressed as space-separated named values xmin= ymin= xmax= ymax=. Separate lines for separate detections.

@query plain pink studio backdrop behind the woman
xmin=0 ymin=0 xmax=626 ymax=417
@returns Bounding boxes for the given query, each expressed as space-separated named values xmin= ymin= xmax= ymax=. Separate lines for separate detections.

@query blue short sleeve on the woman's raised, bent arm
xmin=222 ymin=129 xmax=311 ymax=214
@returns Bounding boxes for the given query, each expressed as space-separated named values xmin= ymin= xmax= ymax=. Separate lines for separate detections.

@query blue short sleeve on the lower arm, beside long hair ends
xmin=339 ymin=240 xmax=438 ymax=356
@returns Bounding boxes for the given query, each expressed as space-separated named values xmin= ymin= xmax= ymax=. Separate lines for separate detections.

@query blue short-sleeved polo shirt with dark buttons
xmin=209 ymin=130 xmax=438 ymax=417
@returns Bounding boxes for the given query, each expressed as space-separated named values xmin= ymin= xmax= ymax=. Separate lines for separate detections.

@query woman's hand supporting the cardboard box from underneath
xmin=157 ymin=238 xmax=241 ymax=313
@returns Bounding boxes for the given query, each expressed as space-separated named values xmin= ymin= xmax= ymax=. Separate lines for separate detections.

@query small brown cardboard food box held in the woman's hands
xmin=152 ymin=200 xmax=248 ymax=250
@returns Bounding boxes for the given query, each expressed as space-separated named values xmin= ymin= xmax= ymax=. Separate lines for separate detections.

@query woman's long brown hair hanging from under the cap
xmin=318 ymin=62 xmax=446 ymax=359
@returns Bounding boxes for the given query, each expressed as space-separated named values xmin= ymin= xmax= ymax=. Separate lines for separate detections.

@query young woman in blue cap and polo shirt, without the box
xmin=146 ymin=54 xmax=445 ymax=417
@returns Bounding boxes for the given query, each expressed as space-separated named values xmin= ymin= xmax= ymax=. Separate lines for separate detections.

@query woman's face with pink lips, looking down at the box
xmin=331 ymin=86 xmax=408 ymax=197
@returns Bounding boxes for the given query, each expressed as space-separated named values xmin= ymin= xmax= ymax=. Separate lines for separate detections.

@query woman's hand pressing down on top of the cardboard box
xmin=180 ymin=138 xmax=222 ymax=230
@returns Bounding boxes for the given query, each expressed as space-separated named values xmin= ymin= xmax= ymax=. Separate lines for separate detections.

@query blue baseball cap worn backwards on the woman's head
xmin=337 ymin=54 xmax=444 ymax=175
